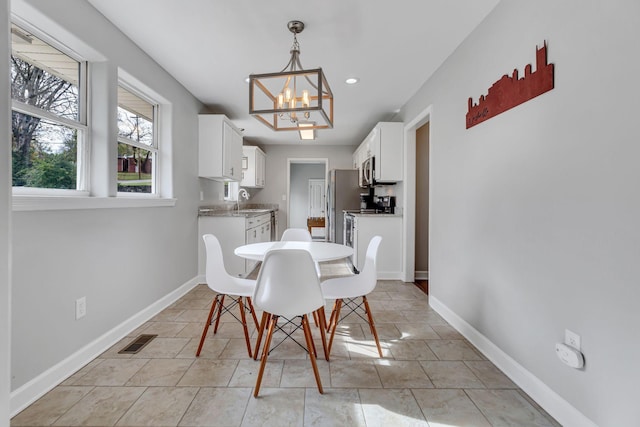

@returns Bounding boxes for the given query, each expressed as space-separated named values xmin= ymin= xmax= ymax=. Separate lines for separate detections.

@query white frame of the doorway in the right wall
xmin=401 ymin=105 xmax=433 ymax=282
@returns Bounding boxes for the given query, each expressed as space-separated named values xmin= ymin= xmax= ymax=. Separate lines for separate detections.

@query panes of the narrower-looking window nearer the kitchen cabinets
xmin=118 ymin=83 xmax=158 ymax=194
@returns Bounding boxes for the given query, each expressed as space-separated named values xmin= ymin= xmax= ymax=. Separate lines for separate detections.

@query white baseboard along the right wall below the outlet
xmin=429 ymin=295 xmax=598 ymax=427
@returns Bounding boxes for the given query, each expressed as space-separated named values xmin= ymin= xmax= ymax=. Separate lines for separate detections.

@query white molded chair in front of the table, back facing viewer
xmin=253 ymin=249 xmax=328 ymax=397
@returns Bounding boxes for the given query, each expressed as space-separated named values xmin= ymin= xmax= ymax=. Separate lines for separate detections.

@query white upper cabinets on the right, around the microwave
xmin=356 ymin=122 xmax=404 ymax=183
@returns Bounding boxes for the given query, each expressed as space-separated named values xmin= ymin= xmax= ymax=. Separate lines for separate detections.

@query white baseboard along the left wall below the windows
xmin=9 ymin=276 xmax=203 ymax=417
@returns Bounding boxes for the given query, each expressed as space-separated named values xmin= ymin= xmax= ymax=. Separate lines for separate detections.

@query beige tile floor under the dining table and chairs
xmin=11 ymin=264 xmax=559 ymax=427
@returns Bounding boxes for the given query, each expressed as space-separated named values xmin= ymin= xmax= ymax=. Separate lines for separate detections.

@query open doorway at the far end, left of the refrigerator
xmin=287 ymin=159 xmax=328 ymax=233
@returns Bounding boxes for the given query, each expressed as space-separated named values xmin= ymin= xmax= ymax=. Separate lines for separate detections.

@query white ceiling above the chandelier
xmin=89 ymin=0 xmax=499 ymax=145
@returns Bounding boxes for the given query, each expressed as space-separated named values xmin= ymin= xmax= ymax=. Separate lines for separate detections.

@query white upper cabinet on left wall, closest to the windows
xmin=198 ymin=114 xmax=242 ymax=181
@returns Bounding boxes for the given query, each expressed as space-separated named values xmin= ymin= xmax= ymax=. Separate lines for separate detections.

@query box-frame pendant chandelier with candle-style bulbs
xmin=249 ymin=21 xmax=333 ymax=139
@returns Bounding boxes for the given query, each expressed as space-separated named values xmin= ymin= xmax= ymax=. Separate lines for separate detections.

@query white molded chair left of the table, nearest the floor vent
xmin=196 ymin=234 xmax=258 ymax=357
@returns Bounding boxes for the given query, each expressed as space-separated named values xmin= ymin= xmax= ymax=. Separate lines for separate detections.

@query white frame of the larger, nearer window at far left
xmin=10 ymin=16 xmax=91 ymax=197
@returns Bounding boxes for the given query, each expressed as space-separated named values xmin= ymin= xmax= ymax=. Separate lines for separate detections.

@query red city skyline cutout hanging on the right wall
xmin=467 ymin=41 xmax=553 ymax=129
